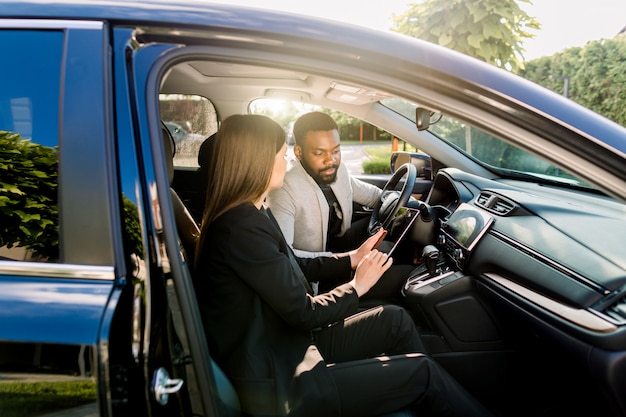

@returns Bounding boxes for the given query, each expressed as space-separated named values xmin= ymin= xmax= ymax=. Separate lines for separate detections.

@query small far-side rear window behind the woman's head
xmin=159 ymin=94 xmax=218 ymax=168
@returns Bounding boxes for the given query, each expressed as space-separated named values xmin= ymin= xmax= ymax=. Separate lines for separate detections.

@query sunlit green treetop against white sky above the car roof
xmin=392 ymin=0 xmax=541 ymax=70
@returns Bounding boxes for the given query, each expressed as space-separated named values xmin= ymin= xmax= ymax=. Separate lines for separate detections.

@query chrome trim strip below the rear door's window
xmin=0 ymin=261 xmax=115 ymax=281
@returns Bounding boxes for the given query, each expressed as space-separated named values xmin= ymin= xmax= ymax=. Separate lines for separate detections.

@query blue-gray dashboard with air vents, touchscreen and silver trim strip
xmin=408 ymin=168 xmax=626 ymax=349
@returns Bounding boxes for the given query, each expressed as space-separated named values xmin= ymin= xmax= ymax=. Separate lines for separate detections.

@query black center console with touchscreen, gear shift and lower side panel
xmin=402 ymin=203 xmax=500 ymax=353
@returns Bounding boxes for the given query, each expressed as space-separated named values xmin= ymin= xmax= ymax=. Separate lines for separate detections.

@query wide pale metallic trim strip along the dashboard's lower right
xmin=484 ymin=272 xmax=617 ymax=333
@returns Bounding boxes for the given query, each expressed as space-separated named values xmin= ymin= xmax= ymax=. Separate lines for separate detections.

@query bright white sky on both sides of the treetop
xmin=216 ymin=0 xmax=626 ymax=61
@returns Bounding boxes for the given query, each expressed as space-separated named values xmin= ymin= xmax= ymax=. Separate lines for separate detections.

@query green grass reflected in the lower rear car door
xmin=0 ymin=381 xmax=96 ymax=417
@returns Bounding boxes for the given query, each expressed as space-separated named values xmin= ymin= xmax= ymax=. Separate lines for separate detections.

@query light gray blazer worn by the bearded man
xmin=267 ymin=160 xmax=382 ymax=258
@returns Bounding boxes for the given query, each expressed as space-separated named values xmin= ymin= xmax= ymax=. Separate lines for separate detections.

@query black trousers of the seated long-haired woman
xmin=314 ymin=305 xmax=491 ymax=417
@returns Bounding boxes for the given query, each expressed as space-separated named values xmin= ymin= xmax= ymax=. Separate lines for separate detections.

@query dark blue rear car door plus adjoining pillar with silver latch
xmin=0 ymin=19 xmax=206 ymax=417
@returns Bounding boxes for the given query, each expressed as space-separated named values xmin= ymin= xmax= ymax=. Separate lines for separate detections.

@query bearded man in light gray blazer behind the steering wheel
xmin=267 ymin=112 xmax=413 ymax=303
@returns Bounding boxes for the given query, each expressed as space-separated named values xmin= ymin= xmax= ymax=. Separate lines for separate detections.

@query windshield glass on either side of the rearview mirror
xmin=380 ymin=98 xmax=590 ymax=187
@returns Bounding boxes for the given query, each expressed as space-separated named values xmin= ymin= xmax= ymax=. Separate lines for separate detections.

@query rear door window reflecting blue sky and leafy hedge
xmin=0 ymin=30 xmax=63 ymax=262
